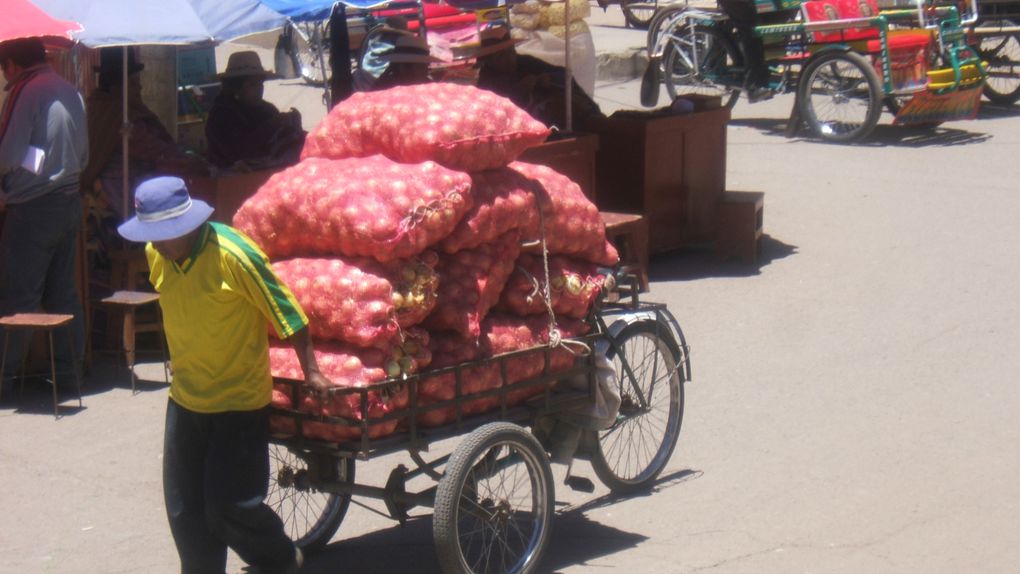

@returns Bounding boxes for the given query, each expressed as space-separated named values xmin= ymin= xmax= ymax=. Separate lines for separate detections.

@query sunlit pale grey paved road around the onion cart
xmin=0 ymin=5 xmax=1020 ymax=574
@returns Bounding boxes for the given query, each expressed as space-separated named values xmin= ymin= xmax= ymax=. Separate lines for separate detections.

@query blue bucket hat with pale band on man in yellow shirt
xmin=117 ymin=176 xmax=212 ymax=243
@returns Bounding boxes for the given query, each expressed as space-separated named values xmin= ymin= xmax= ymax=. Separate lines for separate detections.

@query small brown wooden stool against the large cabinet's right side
xmin=715 ymin=192 xmax=765 ymax=264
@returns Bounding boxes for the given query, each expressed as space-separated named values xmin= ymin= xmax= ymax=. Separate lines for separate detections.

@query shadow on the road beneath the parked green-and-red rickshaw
xmin=729 ymin=116 xmax=991 ymax=148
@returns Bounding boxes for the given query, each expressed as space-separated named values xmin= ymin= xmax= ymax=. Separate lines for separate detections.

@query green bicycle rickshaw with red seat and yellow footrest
xmin=646 ymin=0 xmax=985 ymax=142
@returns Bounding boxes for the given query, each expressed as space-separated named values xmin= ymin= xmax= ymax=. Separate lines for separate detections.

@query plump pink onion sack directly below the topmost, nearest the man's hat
xmin=234 ymin=156 xmax=471 ymax=262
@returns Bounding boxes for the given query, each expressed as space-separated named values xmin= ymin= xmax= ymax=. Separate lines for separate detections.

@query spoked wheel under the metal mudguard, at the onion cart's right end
xmin=592 ymin=320 xmax=685 ymax=493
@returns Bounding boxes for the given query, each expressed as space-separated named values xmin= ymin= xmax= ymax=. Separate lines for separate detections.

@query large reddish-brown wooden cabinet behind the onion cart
xmin=596 ymin=108 xmax=729 ymax=254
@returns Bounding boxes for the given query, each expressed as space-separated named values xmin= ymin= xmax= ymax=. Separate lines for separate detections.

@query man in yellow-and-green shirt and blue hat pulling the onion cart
xmin=117 ymin=176 xmax=330 ymax=574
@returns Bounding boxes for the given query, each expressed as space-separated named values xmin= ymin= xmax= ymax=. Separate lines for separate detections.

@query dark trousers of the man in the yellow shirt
xmin=163 ymin=400 xmax=295 ymax=574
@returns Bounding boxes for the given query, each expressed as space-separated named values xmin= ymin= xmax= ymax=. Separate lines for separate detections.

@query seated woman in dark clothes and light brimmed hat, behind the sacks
xmin=205 ymin=51 xmax=306 ymax=171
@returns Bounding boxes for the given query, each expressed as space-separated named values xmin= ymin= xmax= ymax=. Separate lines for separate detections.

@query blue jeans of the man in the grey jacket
xmin=0 ymin=193 xmax=85 ymax=376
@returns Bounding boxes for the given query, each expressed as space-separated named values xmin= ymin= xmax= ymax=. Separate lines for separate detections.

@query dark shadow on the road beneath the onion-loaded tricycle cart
xmin=301 ymin=470 xmax=702 ymax=574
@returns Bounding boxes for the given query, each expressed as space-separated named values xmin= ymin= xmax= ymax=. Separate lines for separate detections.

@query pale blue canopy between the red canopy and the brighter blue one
xmin=32 ymin=0 xmax=286 ymax=48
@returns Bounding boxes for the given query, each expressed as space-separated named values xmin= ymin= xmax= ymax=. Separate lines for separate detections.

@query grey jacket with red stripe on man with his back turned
xmin=0 ymin=64 xmax=89 ymax=205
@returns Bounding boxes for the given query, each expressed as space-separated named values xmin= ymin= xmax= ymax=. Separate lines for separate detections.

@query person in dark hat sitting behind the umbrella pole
xmin=82 ymin=48 xmax=208 ymax=220
